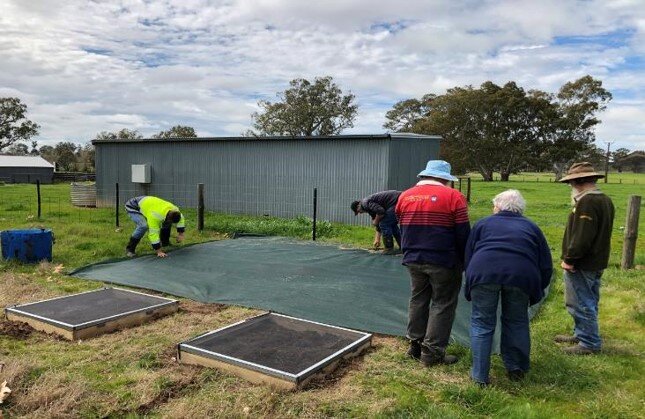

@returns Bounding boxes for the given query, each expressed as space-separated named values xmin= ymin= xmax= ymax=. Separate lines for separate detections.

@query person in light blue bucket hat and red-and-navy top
xmin=396 ymin=160 xmax=470 ymax=367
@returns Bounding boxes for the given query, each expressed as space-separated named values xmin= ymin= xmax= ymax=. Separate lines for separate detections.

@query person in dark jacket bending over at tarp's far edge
xmin=351 ymin=190 xmax=401 ymax=254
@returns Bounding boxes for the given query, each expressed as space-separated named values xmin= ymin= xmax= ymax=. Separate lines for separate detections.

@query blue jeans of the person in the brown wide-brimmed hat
xmin=564 ymin=270 xmax=603 ymax=350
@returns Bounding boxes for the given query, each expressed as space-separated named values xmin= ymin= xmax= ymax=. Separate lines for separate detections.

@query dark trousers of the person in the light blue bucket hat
xmin=407 ymin=263 xmax=461 ymax=357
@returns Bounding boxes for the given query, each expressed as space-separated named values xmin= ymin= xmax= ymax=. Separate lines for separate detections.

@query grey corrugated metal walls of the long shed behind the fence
xmin=93 ymin=133 xmax=440 ymax=224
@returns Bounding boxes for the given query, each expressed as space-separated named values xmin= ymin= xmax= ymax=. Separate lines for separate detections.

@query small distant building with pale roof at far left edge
xmin=0 ymin=155 xmax=54 ymax=183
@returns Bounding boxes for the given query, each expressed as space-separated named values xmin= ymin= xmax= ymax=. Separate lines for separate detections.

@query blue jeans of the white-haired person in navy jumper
xmin=470 ymin=284 xmax=531 ymax=383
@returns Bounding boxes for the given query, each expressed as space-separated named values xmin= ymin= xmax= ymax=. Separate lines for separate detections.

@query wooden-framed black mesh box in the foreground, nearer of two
xmin=178 ymin=313 xmax=372 ymax=389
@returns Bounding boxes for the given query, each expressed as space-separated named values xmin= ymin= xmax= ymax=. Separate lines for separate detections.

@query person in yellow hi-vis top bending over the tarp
xmin=125 ymin=196 xmax=186 ymax=258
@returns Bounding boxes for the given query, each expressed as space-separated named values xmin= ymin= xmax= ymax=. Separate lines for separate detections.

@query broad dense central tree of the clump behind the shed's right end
xmin=412 ymin=81 xmax=550 ymax=181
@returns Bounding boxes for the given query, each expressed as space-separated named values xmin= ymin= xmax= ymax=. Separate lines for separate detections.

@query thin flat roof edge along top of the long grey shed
xmin=92 ymin=132 xmax=441 ymax=144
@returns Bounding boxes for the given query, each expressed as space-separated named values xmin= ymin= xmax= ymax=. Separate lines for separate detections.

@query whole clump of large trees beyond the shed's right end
xmin=384 ymin=76 xmax=611 ymax=180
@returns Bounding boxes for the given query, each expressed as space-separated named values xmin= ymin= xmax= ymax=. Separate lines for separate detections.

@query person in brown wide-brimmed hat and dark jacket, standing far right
xmin=555 ymin=162 xmax=614 ymax=355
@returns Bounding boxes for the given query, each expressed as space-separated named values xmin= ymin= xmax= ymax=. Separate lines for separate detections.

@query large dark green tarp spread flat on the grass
xmin=71 ymin=237 xmax=544 ymax=346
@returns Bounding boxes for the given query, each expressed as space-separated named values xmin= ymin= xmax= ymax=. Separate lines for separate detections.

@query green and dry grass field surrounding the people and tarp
xmin=0 ymin=174 xmax=645 ymax=418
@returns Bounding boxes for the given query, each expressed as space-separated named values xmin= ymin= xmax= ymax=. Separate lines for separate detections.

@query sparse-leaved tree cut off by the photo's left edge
xmin=0 ymin=97 xmax=40 ymax=152
